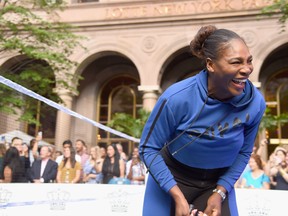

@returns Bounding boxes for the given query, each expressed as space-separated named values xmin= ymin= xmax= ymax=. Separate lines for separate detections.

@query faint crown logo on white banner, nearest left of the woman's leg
xmin=107 ymin=189 xmax=129 ymax=213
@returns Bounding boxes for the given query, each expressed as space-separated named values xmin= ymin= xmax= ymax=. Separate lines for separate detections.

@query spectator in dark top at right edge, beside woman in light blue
xmin=270 ymin=146 xmax=288 ymax=190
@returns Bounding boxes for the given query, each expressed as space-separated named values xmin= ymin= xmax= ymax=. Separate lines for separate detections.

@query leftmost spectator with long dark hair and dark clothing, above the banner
xmin=1 ymin=146 xmax=27 ymax=183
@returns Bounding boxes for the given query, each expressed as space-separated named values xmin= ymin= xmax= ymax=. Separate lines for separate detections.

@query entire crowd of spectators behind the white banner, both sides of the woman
xmin=0 ymin=134 xmax=288 ymax=190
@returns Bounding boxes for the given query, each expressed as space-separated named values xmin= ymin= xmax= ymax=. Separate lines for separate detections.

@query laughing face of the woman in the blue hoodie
xmin=206 ymin=39 xmax=253 ymax=100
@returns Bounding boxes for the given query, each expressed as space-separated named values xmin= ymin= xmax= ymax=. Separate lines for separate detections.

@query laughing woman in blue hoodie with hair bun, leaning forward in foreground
xmin=139 ymin=26 xmax=265 ymax=216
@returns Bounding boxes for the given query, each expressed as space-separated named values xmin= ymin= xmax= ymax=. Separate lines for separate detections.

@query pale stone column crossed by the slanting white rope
xmin=55 ymin=89 xmax=73 ymax=150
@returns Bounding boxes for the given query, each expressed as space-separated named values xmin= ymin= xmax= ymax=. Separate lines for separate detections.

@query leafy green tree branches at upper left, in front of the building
xmin=0 ymin=0 xmax=84 ymax=124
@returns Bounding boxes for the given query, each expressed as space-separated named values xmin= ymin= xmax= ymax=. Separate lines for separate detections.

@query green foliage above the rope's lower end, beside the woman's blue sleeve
xmin=107 ymin=109 xmax=150 ymax=138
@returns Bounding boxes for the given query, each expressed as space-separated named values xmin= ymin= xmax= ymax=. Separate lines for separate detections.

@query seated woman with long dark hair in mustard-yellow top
xmin=57 ymin=147 xmax=82 ymax=183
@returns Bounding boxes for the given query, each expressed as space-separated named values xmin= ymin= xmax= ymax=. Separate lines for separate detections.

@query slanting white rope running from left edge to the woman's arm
xmin=0 ymin=76 xmax=140 ymax=143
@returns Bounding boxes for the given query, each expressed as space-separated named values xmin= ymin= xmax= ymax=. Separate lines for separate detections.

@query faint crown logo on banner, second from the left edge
xmin=47 ymin=189 xmax=70 ymax=210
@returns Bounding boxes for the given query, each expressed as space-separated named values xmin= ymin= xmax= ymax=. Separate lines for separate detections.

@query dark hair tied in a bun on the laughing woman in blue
xmin=190 ymin=25 xmax=245 ymax=60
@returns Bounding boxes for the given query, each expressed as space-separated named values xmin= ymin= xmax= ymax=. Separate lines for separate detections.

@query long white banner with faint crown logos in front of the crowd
xmin=0 ymin=184 xmax=288 ymax=216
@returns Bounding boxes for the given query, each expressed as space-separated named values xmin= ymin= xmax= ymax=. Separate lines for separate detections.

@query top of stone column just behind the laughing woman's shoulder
xmin=138 ymin=86 xmax=160 ymax=111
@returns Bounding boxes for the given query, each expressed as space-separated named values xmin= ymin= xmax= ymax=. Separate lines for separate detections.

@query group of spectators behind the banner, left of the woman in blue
xmin=0 ymin=135 xmax=145 ymax=185
